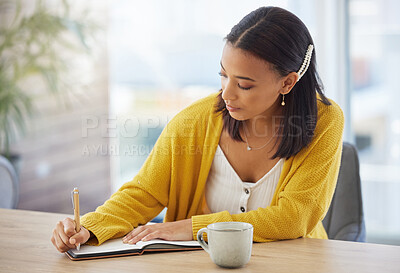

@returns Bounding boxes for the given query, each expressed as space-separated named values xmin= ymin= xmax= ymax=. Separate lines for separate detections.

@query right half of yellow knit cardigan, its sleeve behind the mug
xmin=192 ymin=101 xmax=344 ymax=242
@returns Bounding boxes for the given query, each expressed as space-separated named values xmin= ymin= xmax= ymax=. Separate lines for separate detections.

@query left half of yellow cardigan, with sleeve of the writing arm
xmin=81 ymin=94 xmax=217 ymax=245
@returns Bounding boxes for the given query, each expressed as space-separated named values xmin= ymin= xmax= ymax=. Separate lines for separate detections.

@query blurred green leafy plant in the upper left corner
xmin=0 ymin=0 xmax=95 ymax=156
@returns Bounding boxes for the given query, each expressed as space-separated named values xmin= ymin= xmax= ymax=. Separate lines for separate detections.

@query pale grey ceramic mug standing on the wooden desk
xmin=197 ymin=222 xmax=253 ymax=268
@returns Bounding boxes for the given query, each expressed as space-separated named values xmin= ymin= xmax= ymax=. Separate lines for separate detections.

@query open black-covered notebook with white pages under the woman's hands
xmin=66 ymin=238 xmax=201 ymax=261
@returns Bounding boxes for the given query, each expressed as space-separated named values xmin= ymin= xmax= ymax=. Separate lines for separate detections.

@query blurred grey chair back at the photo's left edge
xmin=0 ymin=155 xmax=18 ymax=209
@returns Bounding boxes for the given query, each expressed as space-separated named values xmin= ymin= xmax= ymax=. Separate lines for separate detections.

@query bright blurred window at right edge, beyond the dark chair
xmin=349 ymin=0 xmax=400 ymax=244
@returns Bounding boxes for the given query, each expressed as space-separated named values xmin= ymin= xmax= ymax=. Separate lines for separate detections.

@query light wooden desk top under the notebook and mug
xmin=0 ymin=209 xmax=400 ymax=273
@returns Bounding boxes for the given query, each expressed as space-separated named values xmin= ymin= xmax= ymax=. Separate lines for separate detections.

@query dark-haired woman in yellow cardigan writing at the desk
xmin=51 ymin=7 xmax=344 ymax=252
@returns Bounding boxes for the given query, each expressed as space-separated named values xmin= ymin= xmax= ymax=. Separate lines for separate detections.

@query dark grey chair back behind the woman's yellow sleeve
xmin=322 ymin=143 xmax=365 ymax=242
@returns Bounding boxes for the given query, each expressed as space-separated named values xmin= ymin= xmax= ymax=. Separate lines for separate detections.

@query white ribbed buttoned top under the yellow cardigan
xmin=205 ymin=145 xmax=285 ymax=214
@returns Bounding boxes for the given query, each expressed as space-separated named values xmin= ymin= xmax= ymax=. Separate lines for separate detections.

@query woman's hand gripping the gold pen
xmin=51 ymin=218 xmax=90 ymax=252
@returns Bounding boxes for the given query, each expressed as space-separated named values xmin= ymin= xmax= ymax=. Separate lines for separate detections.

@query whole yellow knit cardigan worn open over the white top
xmin=81 ymin=91 xmax=344 ymax=244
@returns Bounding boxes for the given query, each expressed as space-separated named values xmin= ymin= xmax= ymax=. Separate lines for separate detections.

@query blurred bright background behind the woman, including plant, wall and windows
xmin=0 ymin=0 xmax=400 ymax=245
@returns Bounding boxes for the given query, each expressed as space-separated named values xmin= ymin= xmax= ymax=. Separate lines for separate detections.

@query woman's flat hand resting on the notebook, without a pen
xmin=122 ymin=219 xmax=193 ymax=244
